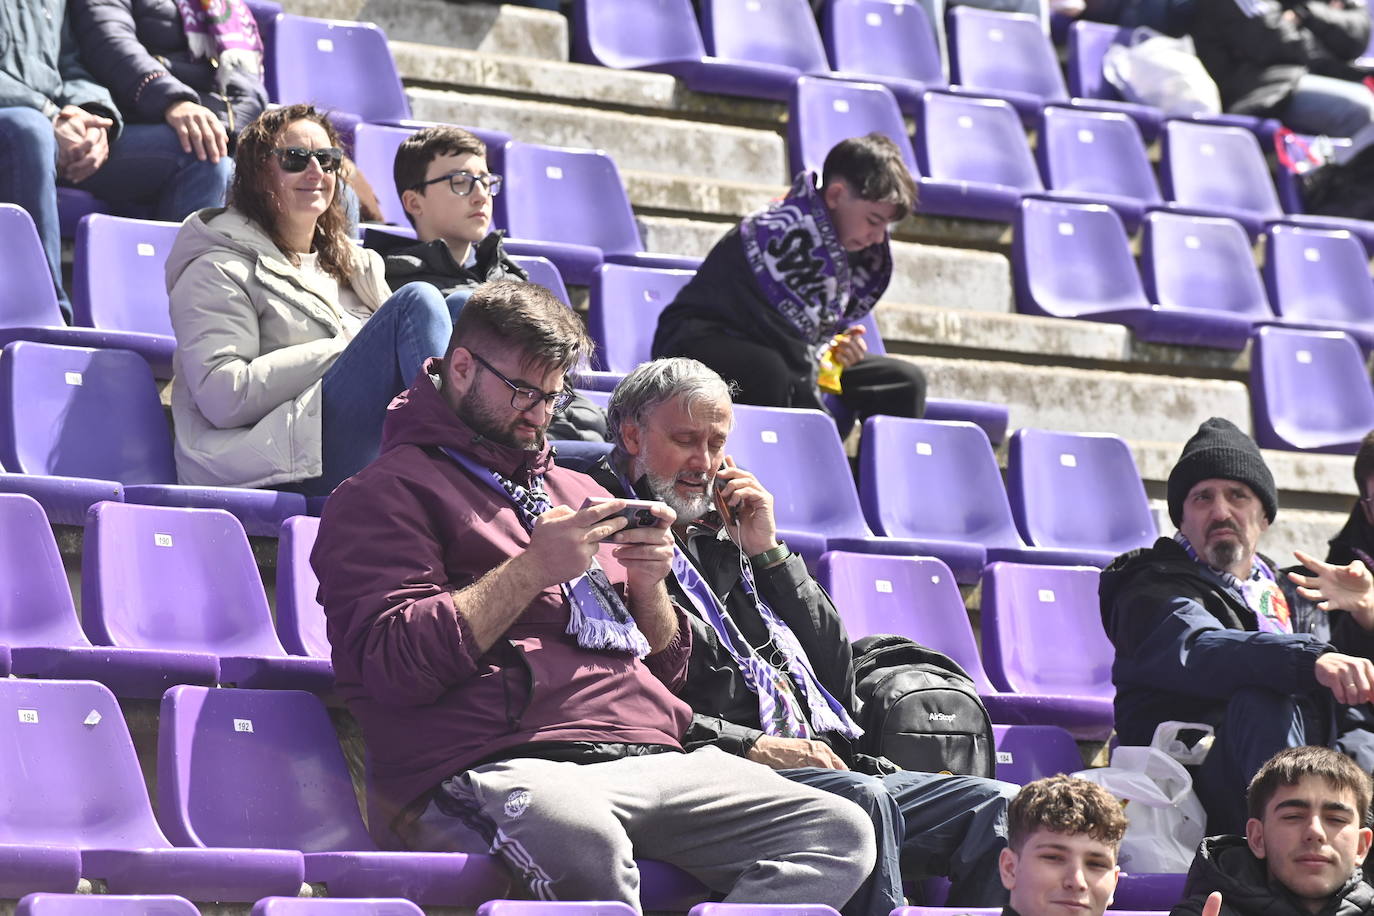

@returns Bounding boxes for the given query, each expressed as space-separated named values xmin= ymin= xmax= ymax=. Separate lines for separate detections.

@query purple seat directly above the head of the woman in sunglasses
xmin=268 ymin=12 xmax=411 ymax=139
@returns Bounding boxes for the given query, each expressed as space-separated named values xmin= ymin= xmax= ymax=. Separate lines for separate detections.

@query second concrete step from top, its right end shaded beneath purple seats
xmin=387 ymin=42 xmax=787 ymax=130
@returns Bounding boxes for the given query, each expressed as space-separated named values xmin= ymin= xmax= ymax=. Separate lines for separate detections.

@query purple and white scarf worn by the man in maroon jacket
xmin=442 ymin=448 xmax=649 ymax=659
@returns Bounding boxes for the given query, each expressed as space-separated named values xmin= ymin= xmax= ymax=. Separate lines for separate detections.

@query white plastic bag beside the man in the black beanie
xmin=1074 ymin=722 xmax=1212 ymax=875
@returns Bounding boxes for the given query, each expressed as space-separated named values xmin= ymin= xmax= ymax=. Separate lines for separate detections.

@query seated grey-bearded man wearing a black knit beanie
xmin=1099 ymin=417 xmax=1374 ymax=834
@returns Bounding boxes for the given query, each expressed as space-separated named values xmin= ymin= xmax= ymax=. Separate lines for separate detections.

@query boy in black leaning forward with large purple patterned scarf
xmin=653 ymin=133 xmax=926 ymax=419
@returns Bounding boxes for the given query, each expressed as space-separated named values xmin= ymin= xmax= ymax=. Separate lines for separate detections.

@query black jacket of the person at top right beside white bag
xmin=1193 ymin=0 xmax=1370 ymax=115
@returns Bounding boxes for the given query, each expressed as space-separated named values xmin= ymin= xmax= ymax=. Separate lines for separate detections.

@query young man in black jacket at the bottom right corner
xmin=1171 ymin=747 xmax=1374 ymax=916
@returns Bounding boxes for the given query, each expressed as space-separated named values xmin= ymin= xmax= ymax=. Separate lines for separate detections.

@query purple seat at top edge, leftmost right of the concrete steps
xmin=572 ymin=0 xmax=801 ymax=102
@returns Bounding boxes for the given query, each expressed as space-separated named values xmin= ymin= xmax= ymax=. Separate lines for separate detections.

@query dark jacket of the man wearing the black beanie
xmin=1098 ymin=537 xmax=1333 ymax=744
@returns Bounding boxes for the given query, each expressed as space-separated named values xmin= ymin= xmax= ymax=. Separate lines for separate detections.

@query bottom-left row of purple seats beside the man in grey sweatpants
xmin=0 ymin=680 xmax=706 ymax=912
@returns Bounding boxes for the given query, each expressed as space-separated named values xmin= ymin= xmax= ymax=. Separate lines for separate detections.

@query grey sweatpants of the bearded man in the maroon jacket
xmin=425 ymin=747 xmax=875 ymax=911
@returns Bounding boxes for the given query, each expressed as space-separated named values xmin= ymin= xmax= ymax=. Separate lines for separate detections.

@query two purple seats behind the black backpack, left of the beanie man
xmin=818 ymin=551 xmax=1114 ymax=740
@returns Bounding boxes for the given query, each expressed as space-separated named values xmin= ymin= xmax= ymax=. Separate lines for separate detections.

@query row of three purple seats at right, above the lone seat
xmin=1011 ymin=197 xmax=1374 ymax=352
